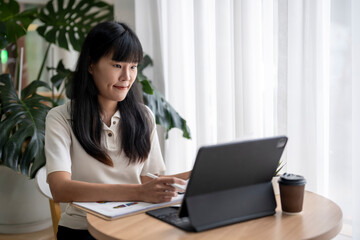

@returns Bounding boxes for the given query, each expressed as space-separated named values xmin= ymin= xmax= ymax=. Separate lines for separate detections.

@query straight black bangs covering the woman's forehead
xmin=112 ymin=30 xmax=143 ymax=63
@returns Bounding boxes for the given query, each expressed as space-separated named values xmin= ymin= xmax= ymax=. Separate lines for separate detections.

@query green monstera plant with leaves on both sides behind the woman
xmin=0 ymin=0 xmax=190 ymax=178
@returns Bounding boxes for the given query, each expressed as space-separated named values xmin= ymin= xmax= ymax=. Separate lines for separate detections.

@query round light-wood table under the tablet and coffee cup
xmin=87 ymin=191 xmax=342 ymax=240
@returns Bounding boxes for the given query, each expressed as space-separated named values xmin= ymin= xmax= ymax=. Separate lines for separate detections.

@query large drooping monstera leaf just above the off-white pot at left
xmin=0 ymin=74 xmax=52 ymax=178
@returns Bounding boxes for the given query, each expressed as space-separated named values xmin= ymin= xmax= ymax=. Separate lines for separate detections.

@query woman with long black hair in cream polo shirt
xmin=45 ymin=22 xmax=189 ymax=240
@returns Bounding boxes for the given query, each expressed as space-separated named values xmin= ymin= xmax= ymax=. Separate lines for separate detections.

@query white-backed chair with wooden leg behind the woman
xmin=35 ymin=167 xmax=61 ymax=240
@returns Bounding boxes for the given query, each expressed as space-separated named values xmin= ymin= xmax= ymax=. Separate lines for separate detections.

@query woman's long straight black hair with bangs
xmin=70 ymin=21 xmax=152 ymax=166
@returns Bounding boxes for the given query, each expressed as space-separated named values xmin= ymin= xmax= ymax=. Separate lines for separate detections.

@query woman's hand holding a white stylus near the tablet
xmin=140 ymin=177 xmax=186 ymax=203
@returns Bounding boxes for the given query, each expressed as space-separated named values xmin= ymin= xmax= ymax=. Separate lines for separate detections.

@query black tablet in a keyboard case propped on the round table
xmin=147 ymin=136 xmax=287 ymax=232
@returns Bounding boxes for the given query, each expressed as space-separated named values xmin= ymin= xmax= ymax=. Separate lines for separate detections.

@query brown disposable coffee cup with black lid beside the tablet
xmin=278 ymin=173 xmax=306 ymax=214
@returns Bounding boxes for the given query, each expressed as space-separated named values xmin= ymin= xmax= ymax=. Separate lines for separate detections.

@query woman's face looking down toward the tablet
xmin=89 ymin=54 xmax=138 ymax=107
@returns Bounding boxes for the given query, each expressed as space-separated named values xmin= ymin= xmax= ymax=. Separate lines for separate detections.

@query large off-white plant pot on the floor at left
xmin=0 ymin=166 xmax=52 ymax=233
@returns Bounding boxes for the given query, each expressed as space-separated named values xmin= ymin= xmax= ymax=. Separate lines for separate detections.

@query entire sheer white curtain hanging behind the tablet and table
xmin=136 ymin=0 xmax=360 ymax=239
